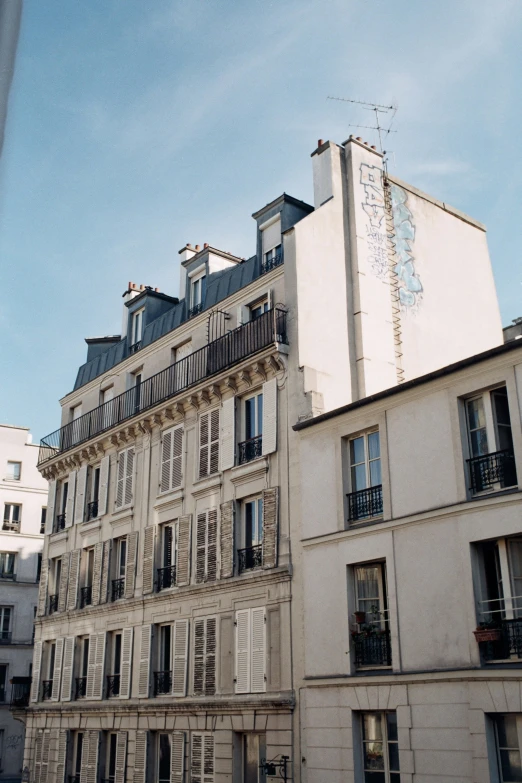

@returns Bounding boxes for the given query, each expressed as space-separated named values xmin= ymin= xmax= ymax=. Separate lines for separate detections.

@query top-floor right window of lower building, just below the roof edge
xmin=465 ymin=386 xmax=517 ymax=494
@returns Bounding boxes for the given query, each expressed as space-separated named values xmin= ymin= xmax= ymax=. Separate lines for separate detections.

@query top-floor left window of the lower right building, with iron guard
xmin=347 ymin=431 xmax=382 ymax=523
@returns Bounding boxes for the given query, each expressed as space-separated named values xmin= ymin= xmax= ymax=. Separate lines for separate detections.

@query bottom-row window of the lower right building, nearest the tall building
xmin=361 ymin=712 xmax=401 ymax=783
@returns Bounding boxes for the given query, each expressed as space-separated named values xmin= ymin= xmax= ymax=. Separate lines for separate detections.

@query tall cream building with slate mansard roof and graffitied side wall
xmin=17 ymin=137 xmax=502 ymax=783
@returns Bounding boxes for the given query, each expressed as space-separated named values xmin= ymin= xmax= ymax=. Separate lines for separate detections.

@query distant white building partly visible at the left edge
xmin=0 ymin=424 xmax=47 ymax=781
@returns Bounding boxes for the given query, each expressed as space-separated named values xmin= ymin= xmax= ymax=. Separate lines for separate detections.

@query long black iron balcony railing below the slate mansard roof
xmin=38 ymin=307 xmax=288 ymax=465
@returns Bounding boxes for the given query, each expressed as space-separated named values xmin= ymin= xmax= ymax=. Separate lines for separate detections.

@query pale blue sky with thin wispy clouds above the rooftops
xmin=0 ymin=0 xmax=522 ymax=439
